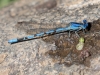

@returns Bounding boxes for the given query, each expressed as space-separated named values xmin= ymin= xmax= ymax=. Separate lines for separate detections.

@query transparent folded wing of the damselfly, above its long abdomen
xmin=15 ymin=21 xmax=66 ymax=34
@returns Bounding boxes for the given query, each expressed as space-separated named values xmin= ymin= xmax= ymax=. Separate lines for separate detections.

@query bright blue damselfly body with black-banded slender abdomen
xmin=8 ymin=20 xmax=88 ymax=44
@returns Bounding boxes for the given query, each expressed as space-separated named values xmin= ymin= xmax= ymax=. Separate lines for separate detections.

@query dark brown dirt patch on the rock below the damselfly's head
xmin=40 ymin=20 xmax=100 ymax=67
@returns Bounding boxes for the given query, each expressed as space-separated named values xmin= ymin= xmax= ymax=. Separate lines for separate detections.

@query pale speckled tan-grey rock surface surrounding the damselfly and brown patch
xmin=0 ymin=0 xmax=100 ymax=75
